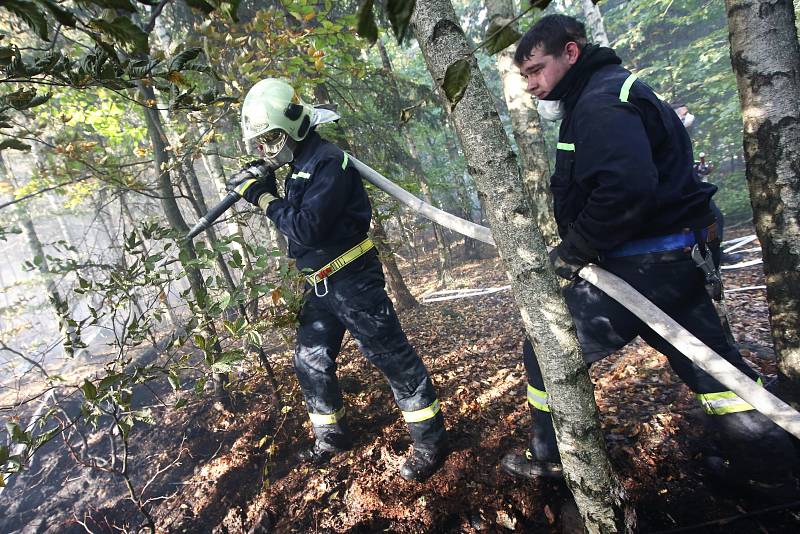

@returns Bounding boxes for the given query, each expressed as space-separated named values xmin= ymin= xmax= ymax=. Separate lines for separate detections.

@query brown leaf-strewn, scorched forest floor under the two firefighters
xmin=0 ymin=227 xmax=800 ymax=533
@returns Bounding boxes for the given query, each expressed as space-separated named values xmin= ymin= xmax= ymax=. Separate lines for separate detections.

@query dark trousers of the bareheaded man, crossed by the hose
xmin=523 ymin=251 xmax=796 ymax=482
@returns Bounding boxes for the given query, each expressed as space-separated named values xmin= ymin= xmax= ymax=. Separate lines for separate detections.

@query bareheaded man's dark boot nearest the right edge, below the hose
xmin=705 ymin=410 xmax=798 ymax=502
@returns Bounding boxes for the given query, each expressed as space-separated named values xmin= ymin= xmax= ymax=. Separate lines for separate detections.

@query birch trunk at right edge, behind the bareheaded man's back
xmin=725 ymin=0 xmax=800 ymax=392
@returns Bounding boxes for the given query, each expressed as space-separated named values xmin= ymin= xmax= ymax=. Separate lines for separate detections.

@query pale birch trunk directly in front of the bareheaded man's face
xmin=486 ymin=0 xmax=560 ymax=246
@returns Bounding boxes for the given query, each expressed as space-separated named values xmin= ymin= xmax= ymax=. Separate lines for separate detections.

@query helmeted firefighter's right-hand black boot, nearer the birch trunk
xmin=400 ymin=412 xmax=449 ymax=482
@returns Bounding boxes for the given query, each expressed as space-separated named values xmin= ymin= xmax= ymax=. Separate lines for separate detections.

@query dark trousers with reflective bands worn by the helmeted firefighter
xmin=294 ymin=253 xmax=446 ymax=451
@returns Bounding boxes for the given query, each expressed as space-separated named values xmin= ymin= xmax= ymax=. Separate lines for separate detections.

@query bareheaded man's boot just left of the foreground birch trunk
xmin=500 ymin=405 xmax=564 ymax=480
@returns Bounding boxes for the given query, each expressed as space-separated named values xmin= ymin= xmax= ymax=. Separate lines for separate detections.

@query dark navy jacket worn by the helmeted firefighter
xmin=266 ymin=131 xmax=372 ymax=270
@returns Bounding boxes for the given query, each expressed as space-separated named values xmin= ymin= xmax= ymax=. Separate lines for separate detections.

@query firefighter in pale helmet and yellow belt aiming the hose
xmin=228 ymin=78 xmax=447 ymax=481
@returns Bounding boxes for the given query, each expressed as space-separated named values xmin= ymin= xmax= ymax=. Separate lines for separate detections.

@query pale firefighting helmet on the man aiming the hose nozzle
xmin=242 ymin=78 xmax=313 ymax=142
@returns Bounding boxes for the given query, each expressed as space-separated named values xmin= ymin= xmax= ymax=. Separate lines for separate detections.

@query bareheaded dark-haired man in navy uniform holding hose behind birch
xmin=501 ymin=15 xmax=795 ymax=487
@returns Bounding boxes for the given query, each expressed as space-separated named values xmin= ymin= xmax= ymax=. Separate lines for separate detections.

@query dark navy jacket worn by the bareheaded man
xmin=551 ymin=65 xmax=716 ymax=255
